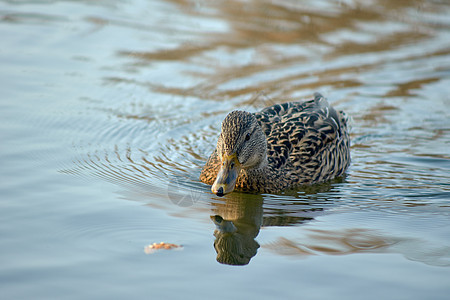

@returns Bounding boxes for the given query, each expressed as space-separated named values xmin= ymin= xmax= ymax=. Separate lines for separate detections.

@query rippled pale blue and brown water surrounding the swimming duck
xmin=0 ymin=0 xmax=450 ymax=299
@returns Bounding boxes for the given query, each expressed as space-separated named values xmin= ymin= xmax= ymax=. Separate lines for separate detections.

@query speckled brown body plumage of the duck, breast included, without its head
xmin=200 ymin=93 xmax=350 ymax=192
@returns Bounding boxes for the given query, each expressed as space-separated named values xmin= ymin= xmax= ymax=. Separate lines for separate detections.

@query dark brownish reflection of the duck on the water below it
xmin=211 ymin=180 xmax=340 ymax=265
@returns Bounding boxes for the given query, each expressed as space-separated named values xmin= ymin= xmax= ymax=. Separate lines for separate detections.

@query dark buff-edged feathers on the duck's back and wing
xmin=255 ymin=94 xmax=347 ymax=184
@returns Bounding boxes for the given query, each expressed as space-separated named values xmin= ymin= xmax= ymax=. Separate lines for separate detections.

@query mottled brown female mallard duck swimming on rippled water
xmin=200 ymin=93 xmax=350 ymax=196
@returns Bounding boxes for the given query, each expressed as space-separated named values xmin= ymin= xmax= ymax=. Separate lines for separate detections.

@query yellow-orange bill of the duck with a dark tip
xmin=211 ymin=154 xmax=241 ymax=197
